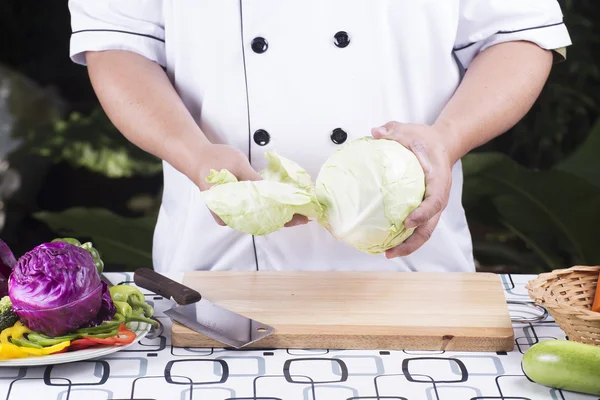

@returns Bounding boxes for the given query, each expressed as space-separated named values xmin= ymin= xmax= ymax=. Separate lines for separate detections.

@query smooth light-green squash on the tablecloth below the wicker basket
xmin=522 ymin=340 xmax=600 ymax=396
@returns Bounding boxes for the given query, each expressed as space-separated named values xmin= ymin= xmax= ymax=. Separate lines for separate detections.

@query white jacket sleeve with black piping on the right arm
xmin=454 ymin=0 xmax=571 ymax=68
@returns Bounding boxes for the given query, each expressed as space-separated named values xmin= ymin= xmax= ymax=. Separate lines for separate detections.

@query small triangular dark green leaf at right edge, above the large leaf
xmin=555 ymin=119 xmax=600 ymax=187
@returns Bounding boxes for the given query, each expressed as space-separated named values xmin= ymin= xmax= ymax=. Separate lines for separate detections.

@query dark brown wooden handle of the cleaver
xmin=133 ymin=268 xmax=202 ymax=305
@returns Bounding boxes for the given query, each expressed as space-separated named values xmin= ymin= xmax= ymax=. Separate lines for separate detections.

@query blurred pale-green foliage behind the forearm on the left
xmin=25 ymin=108 xmax=162 ymax=178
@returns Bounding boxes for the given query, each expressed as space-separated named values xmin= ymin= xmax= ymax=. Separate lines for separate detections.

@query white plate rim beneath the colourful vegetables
xmin=0 ymin=322 xmax=150 ymax=367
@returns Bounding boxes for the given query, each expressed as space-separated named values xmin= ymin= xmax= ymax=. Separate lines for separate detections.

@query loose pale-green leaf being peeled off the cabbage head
xmin=201 ymin=152 xmax=322 ymax=235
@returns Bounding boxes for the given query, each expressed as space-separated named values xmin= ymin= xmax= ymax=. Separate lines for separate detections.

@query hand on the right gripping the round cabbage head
xmin=371 ymin=122 xmax=454 ymax=258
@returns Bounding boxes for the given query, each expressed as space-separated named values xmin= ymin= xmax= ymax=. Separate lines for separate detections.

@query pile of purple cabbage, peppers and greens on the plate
xmin=0 ymin=238 xmax=157 ymax=359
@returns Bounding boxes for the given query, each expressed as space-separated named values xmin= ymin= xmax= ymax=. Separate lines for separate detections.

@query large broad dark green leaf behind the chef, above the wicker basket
xmin=463 ymin=153 xmax=600 ymax=268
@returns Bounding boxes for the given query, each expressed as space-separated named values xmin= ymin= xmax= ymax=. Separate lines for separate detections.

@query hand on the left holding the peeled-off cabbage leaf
xmin=195 ymin=143 xmax=309 ymax=227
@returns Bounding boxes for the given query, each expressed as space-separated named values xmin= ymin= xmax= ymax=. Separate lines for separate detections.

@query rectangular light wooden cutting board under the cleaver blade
xmin=172 ymin=271 xmax=514 ymax=351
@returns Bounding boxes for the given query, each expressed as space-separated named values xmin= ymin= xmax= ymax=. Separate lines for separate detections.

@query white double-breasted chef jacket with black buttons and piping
xmin=69 ymin=0 xmax=571 ymax=272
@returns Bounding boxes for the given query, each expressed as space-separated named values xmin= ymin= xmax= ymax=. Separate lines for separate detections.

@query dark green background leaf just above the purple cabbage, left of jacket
xmin=34 ymin=207 xmax=156 ymax=268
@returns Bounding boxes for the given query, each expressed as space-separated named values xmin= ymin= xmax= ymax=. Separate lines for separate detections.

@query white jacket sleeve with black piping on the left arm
xmin=69 ymin=0 xmax=166 ymax=67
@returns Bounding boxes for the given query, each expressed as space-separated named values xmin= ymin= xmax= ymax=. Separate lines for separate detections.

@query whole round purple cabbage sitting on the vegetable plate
xmin=8 ymin=242 xmax=103 ymax=336
